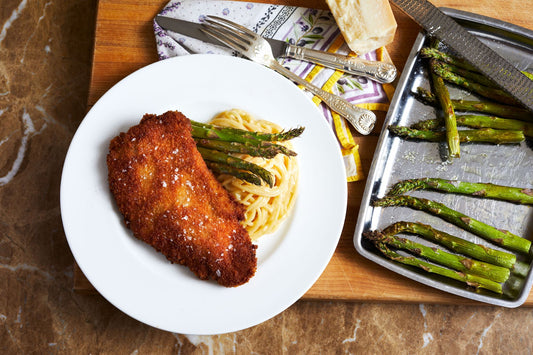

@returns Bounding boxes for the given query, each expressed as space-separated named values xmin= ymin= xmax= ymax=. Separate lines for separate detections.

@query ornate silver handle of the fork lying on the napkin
xmin=268 ymin=59 xmax=376 ymax=135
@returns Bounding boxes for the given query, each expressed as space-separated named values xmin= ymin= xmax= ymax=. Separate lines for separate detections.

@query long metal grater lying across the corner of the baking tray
xmin=391 ymin=0 xmax=533 ymax=112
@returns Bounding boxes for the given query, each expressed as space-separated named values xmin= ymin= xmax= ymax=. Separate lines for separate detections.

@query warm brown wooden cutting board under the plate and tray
xmin=74 ymin=0 xmax=533 ymax=306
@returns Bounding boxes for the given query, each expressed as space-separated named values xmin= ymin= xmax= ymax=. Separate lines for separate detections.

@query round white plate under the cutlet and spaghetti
xmin=61 ymin=55 xmax=347 ymax=334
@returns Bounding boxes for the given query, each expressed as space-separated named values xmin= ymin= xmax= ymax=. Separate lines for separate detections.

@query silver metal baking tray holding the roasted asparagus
xmin=354 ymin=8 xmax=533 ymax=307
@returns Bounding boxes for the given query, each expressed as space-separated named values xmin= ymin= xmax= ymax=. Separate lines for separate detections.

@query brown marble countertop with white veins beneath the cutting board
xmin=0 ymin=0 xmax=533 ymax=354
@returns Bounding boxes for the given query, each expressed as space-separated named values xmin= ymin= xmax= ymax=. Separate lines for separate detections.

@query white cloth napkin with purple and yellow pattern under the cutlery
xmin=154 ymin=0 xmax=394 ymax=181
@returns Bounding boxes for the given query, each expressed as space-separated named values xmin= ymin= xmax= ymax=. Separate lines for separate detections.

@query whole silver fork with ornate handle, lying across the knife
xmin=203 ymin=16 xmax=376 ymax=135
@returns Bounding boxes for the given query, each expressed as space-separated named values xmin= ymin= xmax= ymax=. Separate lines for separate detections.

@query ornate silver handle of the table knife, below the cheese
xmin=285 ymin=44 xmax=397 ymax=84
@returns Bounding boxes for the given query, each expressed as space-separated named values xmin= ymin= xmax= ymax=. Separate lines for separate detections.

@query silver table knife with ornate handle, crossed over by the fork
xmin=155 ymin=15 xmax=397 ymax=83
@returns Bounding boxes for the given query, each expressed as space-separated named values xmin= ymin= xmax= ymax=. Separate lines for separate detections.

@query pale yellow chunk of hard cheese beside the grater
xmin=326 ymin=0 xmax=397 ymax=54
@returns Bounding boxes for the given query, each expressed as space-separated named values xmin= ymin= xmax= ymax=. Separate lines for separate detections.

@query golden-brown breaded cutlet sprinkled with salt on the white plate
xmin=107 ymin=111 xmax=257 ymax=287
